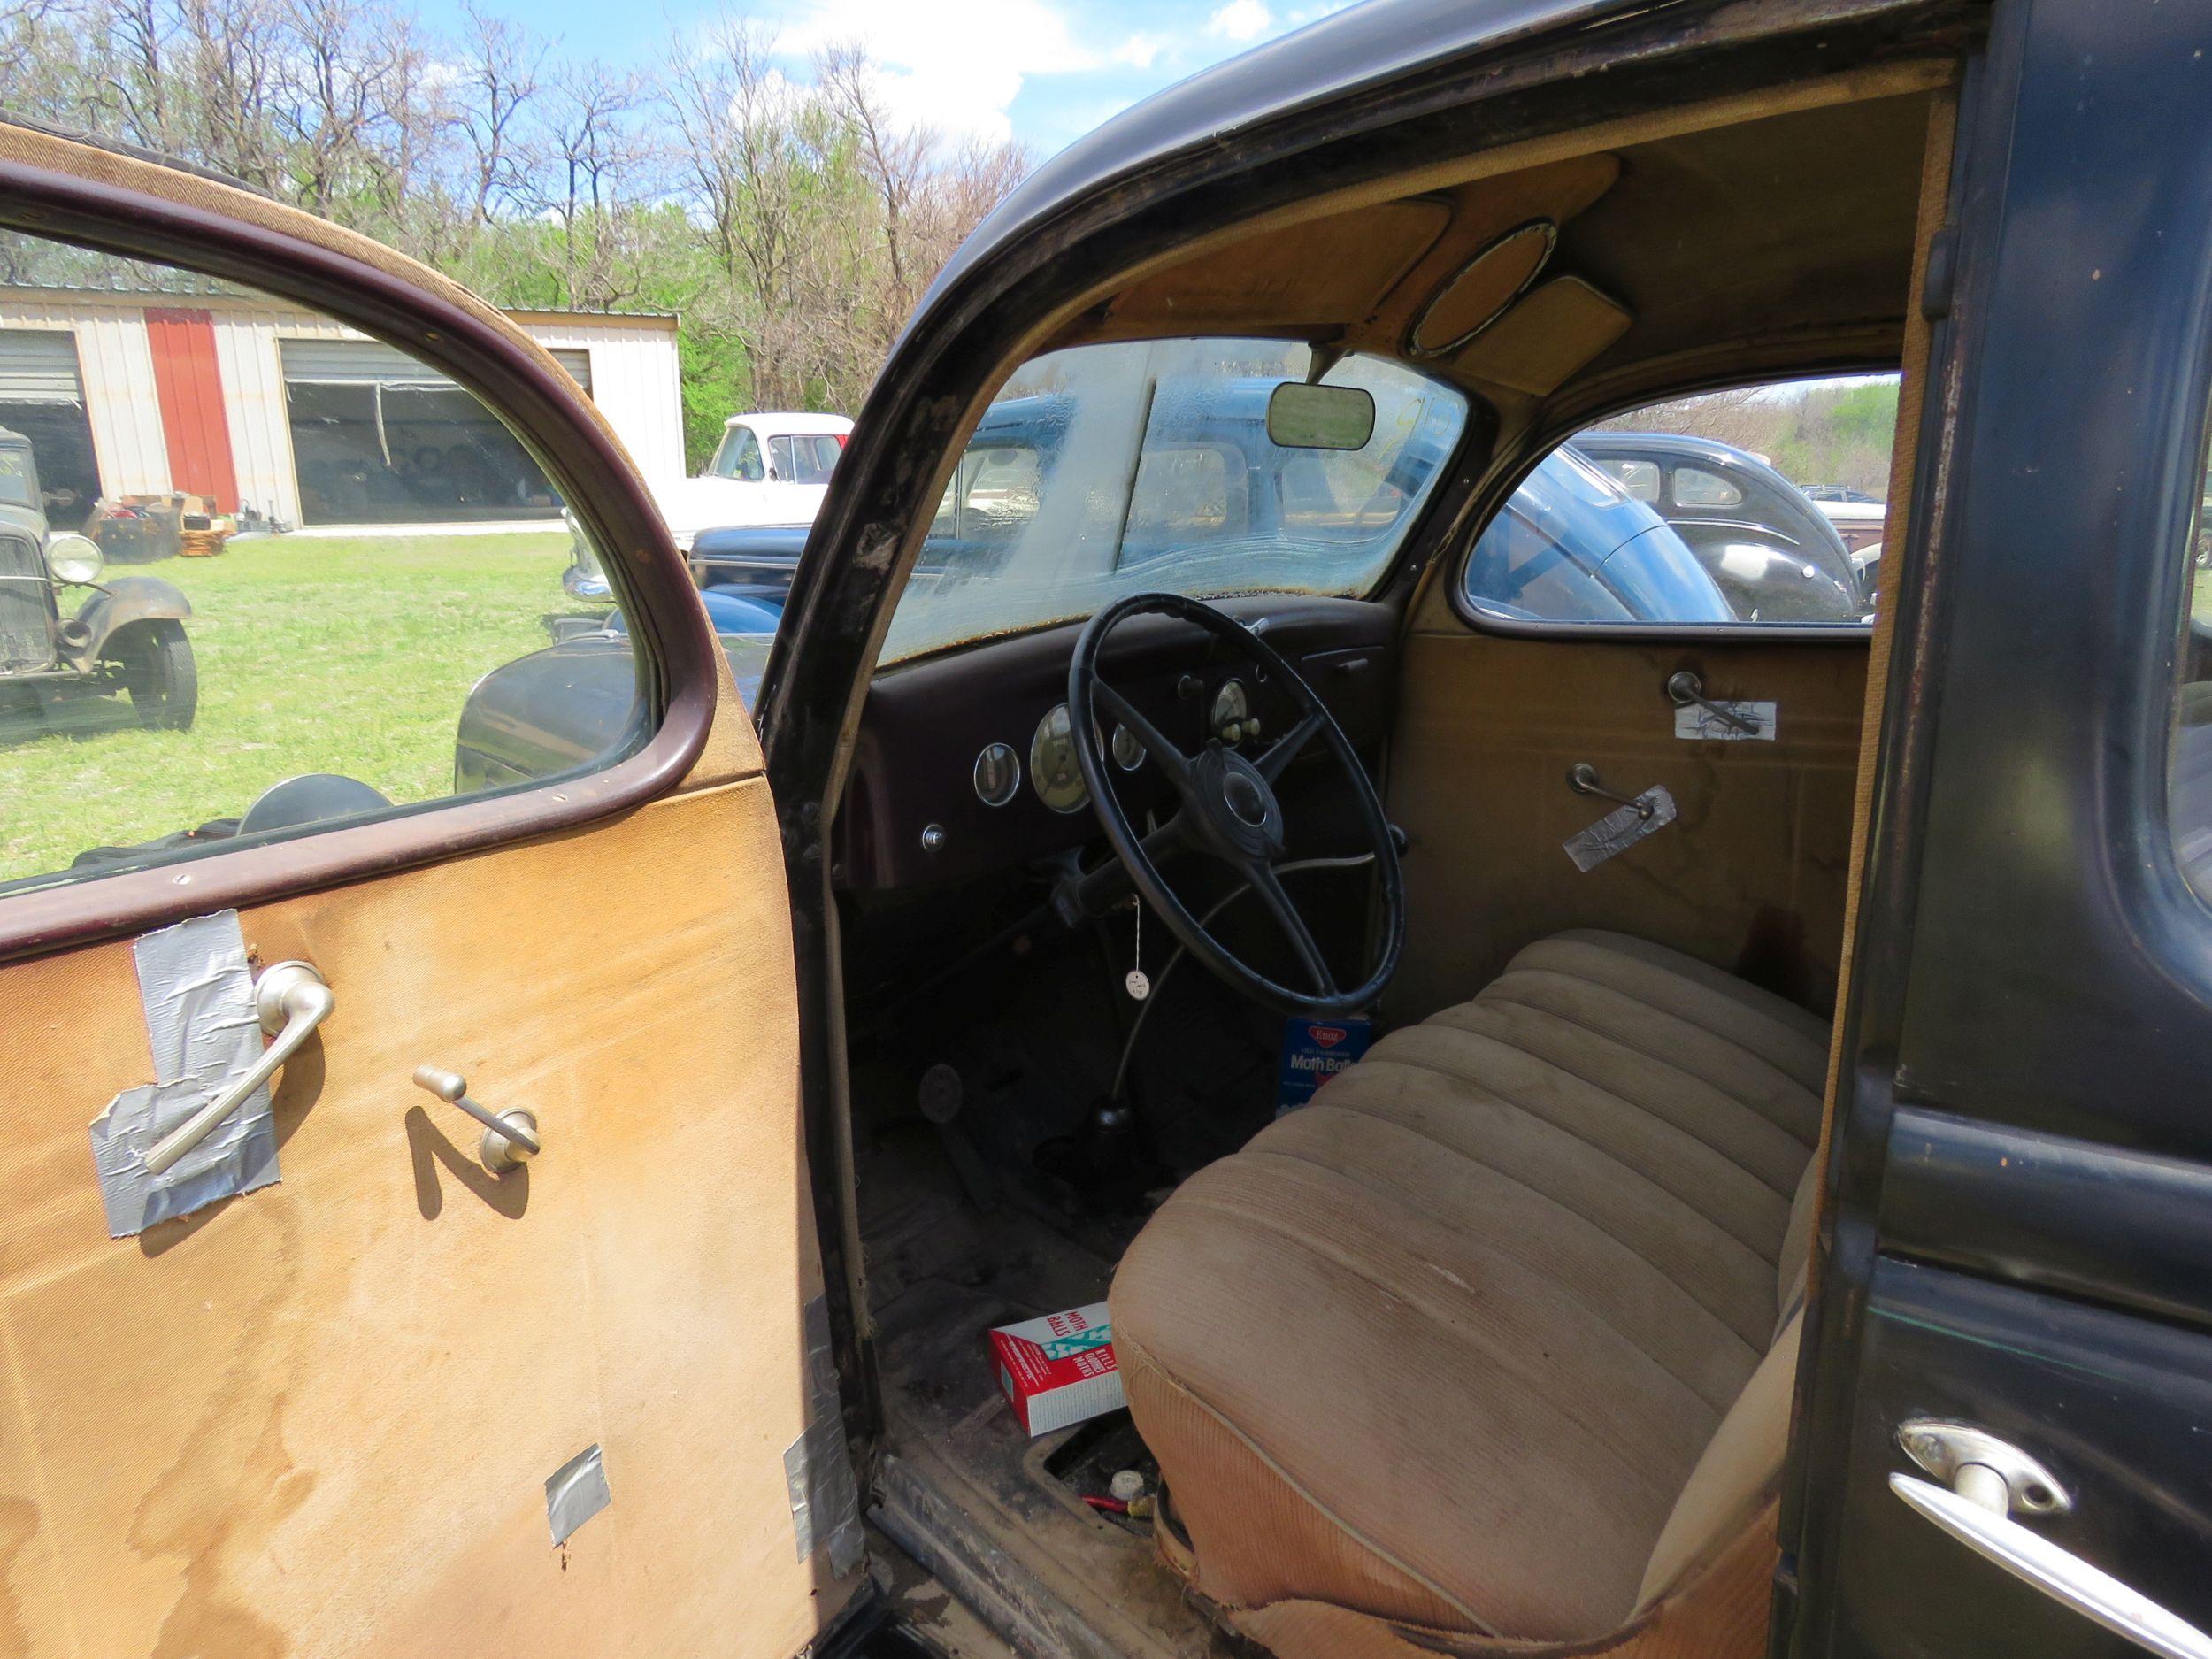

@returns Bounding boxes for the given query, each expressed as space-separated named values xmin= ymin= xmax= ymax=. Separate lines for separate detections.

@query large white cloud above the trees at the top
xmin=774 ymin=0 xmax=1164 ymax=140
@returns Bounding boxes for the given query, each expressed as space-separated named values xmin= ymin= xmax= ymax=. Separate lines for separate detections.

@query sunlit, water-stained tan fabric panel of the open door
xmin=0 ymin=779 xmax=849 ymax=1659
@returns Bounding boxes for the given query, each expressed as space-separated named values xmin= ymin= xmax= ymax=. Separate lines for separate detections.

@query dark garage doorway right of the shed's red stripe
xmin=281 ymin=341 xmax=591 ymax=525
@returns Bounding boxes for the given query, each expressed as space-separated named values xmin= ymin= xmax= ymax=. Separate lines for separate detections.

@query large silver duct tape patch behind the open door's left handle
xmin=91 ymin=910 xmax=279 ymax=1239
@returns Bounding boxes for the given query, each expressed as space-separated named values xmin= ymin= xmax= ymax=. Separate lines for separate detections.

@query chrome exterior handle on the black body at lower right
xmin=1889 ymin=1420 xmax=2212 ymax=1659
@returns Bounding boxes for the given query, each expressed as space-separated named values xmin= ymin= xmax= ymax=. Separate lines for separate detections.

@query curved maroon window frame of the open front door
xmin=0 ymin=149 xmax=719 ymax=963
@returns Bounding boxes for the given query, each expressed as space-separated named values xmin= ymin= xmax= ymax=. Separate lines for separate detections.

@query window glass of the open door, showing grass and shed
xmin=0 ymin=234 xmax=650 ymax=892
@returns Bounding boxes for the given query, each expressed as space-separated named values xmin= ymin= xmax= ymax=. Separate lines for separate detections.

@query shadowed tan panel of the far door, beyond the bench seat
xmin=1387 ymin=637 xmax=1867 ymax=1025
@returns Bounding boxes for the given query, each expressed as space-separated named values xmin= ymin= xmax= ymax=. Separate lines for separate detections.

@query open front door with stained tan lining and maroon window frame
xmin=0 ymin=127 xmax=863 ymax=1659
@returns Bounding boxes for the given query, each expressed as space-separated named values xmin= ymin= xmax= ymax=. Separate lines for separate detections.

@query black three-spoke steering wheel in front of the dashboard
xmin=1069 ymin=593 xmax=1405 ymax=1018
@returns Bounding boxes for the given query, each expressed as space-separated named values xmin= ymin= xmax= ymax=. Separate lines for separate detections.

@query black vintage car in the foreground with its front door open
xmin=12 ymin=0 xmax=2212 ymax=1659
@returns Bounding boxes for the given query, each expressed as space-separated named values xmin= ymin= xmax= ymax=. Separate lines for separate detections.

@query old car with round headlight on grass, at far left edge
xmin=0 ymin=427 xmax=199 ymax=739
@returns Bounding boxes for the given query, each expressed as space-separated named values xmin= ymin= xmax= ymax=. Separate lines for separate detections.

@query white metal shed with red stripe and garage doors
xmin=0 ymin=286 xmax=684 ymax=529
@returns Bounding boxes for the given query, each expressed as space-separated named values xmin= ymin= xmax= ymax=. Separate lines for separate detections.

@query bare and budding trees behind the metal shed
xmin=0 ymin=0 xmax=1029 ymax=463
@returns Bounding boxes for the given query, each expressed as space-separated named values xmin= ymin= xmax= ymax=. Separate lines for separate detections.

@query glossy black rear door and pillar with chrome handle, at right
xmin=1778 ymin=0 xmax=2212 ymax=1659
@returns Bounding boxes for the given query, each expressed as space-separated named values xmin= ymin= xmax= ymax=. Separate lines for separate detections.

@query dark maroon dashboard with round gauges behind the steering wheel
xmin=834 ymin=595 xmax=1398 ymax=892
